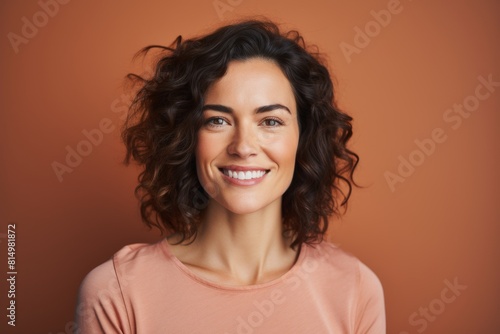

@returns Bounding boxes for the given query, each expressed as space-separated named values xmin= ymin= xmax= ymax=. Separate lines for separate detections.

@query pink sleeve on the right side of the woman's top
xmin=355 ymin=262 xmax=386 ymax=334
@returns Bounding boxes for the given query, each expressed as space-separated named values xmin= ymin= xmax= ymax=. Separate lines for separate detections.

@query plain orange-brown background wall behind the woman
xmin=0 ymin=0 xmax=500 ymax=334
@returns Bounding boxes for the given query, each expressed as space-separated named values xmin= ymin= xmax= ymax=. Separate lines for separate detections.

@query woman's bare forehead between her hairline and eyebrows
xmin=205 ymin=58 xmax=295 ymax=110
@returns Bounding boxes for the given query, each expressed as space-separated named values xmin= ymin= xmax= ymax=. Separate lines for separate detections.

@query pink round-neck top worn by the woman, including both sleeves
xmin=76 ymin=239 xmax=386 ymax=334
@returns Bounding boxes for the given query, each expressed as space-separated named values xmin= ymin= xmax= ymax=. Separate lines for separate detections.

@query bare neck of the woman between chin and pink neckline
xmin=186 ymin=201 xmax=296 ymax=284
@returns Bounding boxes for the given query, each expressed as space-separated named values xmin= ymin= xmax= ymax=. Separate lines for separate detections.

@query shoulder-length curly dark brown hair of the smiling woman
xmin=122 ymin=20 xmax=359 ymax=247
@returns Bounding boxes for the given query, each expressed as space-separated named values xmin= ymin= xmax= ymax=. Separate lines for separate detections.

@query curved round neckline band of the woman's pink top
xmin=161 ymin=238 xmax=308 ymax=291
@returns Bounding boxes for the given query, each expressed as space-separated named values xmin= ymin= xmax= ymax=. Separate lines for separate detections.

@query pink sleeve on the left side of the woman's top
xmin=75 ymin=260 xmax=130 ymax=334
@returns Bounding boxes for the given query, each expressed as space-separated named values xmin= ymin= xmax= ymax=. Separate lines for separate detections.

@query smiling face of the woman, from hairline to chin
xmin=196 ymin=58 xmax=299 ymax=214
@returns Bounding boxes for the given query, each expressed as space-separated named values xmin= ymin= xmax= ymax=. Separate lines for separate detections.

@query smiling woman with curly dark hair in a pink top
xmin=77 ymin=21 xmax=385 ymax=334
